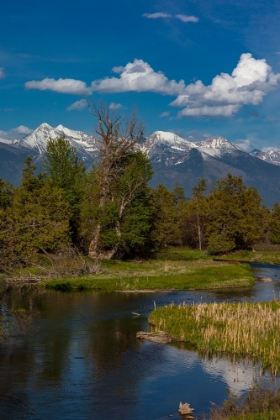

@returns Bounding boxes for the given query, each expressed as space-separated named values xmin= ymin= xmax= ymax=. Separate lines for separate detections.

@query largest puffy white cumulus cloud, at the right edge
xmin=171 ymin=54 xmax=280 ymax=117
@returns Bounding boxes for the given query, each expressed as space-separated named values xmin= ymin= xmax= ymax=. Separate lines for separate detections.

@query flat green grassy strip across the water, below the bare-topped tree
xmin=45 ymin=259 xmax=255 ymax=292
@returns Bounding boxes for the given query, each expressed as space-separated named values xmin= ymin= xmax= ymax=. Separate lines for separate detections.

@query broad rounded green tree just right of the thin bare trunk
xmin=206 ymin=174 xmax=268 ymax=254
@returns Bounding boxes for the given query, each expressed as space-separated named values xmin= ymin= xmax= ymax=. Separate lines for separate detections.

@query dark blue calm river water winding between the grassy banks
xmin=0 ymin=264 xmax=280 ymax=420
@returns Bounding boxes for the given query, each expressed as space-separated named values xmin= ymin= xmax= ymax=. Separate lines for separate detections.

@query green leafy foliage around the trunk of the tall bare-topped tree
xmin=81 ymin=152 xmax=153 ymax=256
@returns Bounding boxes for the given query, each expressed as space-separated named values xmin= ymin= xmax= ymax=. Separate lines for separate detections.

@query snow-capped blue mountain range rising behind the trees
xmin=0 ymin=123 xmax=280 ymax=206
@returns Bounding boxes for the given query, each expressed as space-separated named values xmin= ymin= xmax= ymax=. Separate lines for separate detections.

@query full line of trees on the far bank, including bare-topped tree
xmin=0 ymin=106 xmax=280 ymax=269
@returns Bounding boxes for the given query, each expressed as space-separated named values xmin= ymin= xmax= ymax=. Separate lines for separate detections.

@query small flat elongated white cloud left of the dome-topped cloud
xmin=25 ymin=78 xmax=91 ymax=95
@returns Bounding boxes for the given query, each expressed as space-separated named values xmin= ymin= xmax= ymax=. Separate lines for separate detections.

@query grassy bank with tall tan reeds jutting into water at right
xmin=149 ymin=301 xmax=280 ymax=374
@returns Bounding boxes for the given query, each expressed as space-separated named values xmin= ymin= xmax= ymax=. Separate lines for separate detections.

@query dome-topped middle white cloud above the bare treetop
xmin=91 ymin=59 xmax=185 ymax=95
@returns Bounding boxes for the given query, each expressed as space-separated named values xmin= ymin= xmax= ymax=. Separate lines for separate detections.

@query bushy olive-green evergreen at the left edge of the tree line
xmin=0 ymin=158 xmax=70 ymax=270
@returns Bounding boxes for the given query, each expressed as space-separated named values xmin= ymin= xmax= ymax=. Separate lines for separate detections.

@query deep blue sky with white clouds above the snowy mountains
xmin=0 ymin=0 xmax=280 ymax=151
